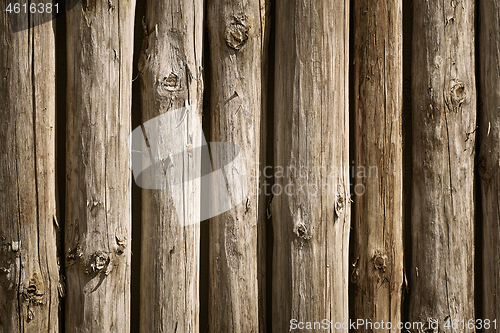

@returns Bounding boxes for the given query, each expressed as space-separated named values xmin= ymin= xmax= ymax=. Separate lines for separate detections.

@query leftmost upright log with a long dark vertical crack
xmin=0 ymin=5 xmax=59 ymax=332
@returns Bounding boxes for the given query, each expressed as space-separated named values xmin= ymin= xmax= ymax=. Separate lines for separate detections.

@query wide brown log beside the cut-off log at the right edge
xmin=408 ymin=0 xmax=476 ymax=332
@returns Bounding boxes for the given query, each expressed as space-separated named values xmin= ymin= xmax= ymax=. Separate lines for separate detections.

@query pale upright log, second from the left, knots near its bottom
xmin=64 ymin=0 xmax=135 ymax=332
